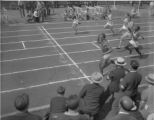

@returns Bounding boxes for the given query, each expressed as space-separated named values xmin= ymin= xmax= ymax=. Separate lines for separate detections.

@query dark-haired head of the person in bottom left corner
xmin=14 ymin=93 xmax=29 ymax=111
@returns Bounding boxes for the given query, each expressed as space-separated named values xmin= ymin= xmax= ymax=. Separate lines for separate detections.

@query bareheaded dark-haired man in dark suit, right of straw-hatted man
xmin=120 ymin=60 xmax=142 ymax=103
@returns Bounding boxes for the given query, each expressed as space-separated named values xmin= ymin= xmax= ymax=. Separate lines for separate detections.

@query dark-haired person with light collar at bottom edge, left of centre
xmin=49 ymin=95 xmax=89 ymax=120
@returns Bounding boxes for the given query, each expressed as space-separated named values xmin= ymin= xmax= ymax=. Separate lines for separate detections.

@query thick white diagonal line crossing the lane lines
xmin=42 ymin=26 xmax=91 ymax=82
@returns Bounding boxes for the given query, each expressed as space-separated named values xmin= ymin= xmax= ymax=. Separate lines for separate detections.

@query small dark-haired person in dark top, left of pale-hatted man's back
xmin=50 ymin=86 xmax=67 ymax=113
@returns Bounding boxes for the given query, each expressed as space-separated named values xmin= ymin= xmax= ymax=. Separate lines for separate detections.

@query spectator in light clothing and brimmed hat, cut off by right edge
xmin=140 ymin=73 xmax=154 ymax=117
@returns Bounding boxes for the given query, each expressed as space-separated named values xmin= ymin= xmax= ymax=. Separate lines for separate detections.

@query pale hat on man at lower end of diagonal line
xmin=91 ymin=72 xmax=103 ymax=83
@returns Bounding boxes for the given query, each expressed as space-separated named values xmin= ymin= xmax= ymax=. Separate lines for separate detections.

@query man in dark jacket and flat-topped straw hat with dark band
xmin=107 ymin=57 xmax=129 ymax=94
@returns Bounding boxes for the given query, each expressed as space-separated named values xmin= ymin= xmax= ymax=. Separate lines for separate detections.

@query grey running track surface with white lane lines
xmin=1 ymin=14 xmax=154 ymax=116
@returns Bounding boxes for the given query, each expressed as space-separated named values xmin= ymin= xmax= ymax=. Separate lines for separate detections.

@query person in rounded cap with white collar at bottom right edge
xmin=108 ymin=96 xmax=137 ymax=120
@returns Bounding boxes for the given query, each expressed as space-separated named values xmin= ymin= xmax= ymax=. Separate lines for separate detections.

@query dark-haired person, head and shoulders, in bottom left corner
xmin=6 ymin=93 xmax=42 ymax=120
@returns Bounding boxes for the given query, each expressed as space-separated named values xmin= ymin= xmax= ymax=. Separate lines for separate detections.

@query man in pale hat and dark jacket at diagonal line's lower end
xmin=79 ymin=72 xmax=104 ymax=120
